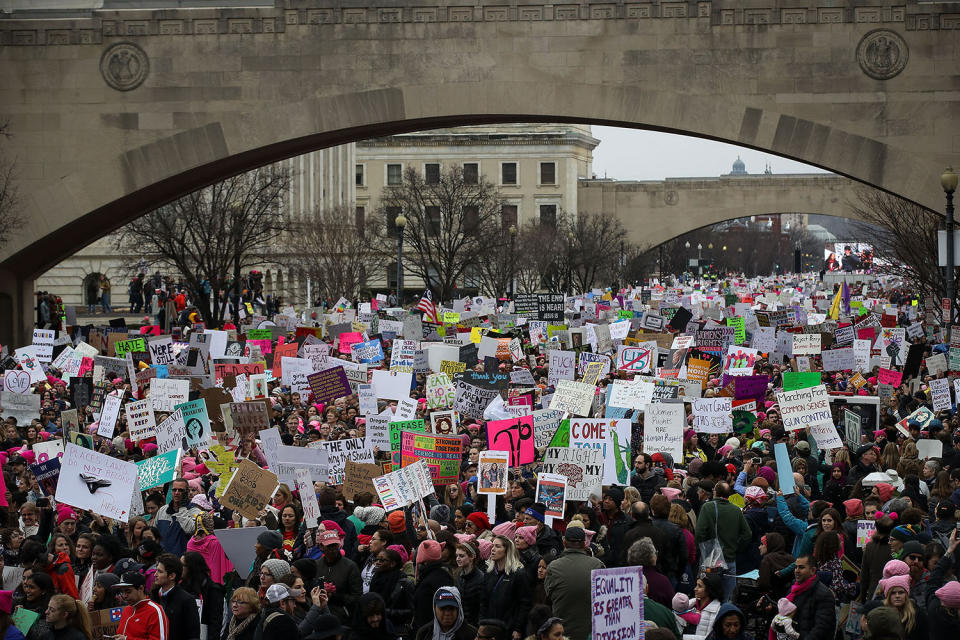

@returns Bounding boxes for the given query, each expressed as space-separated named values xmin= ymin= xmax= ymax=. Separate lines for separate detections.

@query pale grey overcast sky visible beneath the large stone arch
xmin=593 ymin=126 xmax=825 ymax=180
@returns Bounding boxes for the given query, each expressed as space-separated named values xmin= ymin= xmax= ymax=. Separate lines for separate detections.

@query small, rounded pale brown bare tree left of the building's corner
xmin=279 ymin=205 xmax=392 ymax=304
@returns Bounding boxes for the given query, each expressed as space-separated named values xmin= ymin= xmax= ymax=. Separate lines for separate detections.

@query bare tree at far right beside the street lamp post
xmin=850 ymin=189 xmax=944 ymax=309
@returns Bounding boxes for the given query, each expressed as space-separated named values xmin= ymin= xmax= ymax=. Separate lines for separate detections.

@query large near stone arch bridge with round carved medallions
xmin=0 ymin=0 xmax=960 ymax=339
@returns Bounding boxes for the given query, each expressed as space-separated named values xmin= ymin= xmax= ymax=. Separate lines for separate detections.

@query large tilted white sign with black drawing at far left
xmin=56 ymin=444 xmax=137 ymax=522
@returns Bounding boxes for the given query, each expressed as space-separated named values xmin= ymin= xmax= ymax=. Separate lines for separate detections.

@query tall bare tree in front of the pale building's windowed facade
xmin=377 ymin=165 xmax=504 ymax=300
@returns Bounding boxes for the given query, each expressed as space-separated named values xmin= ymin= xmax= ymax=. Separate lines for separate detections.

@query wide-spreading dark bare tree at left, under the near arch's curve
xmin=117 ymin=166 xmax=290 ymax=326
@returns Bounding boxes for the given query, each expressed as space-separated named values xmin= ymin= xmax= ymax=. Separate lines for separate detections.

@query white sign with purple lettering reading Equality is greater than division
xmin=590 ymin=567 xmax=644 ymax=640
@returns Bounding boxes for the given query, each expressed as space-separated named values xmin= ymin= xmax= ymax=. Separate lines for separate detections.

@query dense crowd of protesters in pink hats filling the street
xmin=0 ymin=276 xmax=960 ymax=640
